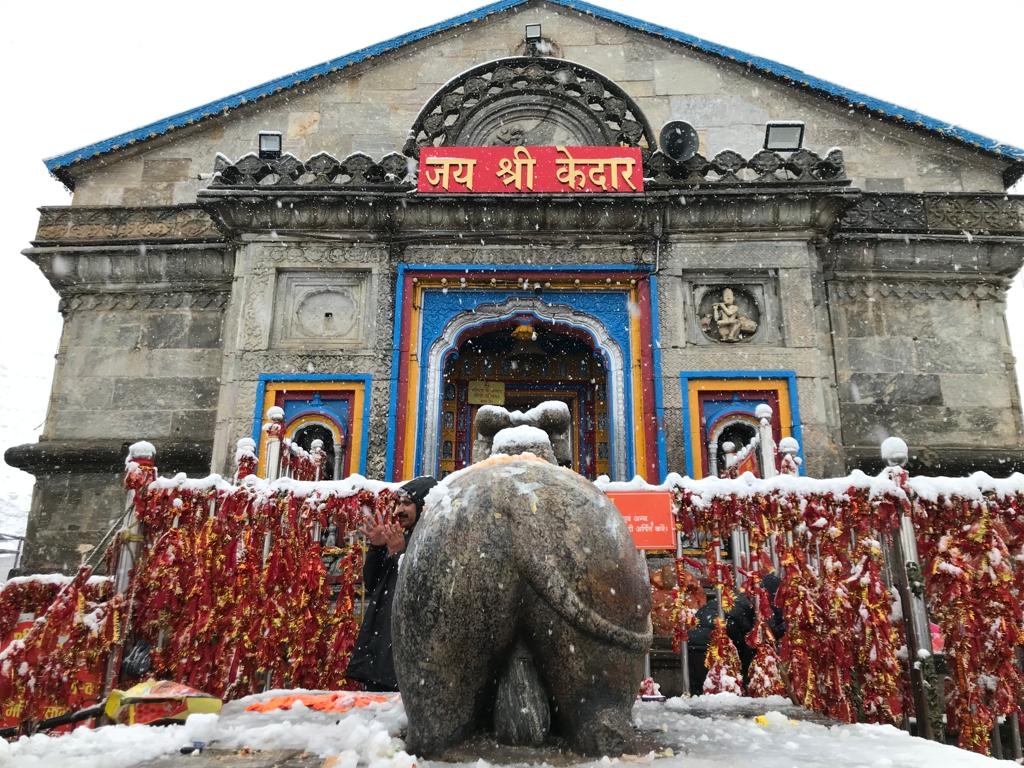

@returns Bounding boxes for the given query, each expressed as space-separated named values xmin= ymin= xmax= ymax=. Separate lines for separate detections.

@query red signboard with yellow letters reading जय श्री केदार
xmin=417 ymin=146 xmax=643 ymax=195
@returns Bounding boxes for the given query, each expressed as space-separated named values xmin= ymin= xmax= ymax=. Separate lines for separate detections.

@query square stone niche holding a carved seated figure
xmin=683 ymin=272 xmax=781 ymax=345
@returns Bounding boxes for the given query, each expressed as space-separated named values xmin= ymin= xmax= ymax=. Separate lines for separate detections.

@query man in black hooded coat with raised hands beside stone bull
xmin=345 ymin=476 xmax=437 ymax=691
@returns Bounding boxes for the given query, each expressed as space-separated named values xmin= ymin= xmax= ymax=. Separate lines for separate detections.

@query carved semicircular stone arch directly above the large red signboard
xmin=403 ymin=56 xmax=657 ymax=157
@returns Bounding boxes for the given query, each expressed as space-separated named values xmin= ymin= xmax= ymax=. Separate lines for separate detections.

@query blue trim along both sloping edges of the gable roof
xmin=43 ymin=0 xmax=1024 ymax=175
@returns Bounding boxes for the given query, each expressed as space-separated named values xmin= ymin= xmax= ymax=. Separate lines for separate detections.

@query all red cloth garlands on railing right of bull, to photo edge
xmin=675 ymin=475 xmax=1024 ymax=752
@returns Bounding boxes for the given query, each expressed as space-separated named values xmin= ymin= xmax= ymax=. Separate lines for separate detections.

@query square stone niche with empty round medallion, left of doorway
xmin=270 ymin=269 xmax=376 ymax=348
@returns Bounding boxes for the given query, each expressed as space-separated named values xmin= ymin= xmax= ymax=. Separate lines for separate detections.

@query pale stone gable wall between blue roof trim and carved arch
xmin=66 ymin=6 xmax=1004 ymax=206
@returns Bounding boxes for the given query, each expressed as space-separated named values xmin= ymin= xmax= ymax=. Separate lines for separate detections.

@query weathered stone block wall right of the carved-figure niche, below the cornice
xmin=828 ymin=241 xmax=1024 ymax=474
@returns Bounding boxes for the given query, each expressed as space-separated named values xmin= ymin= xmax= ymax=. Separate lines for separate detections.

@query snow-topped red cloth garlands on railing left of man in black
xmin=124 ymin=485 xmax=394 ymax=698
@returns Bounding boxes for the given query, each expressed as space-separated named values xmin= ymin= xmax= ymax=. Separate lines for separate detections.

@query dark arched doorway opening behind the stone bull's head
xmin=438 ymin=317 xmax=609 ymax=479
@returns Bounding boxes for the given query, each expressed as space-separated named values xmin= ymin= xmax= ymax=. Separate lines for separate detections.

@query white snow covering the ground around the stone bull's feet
xmin=0 ymin=691 xmax=1013 ymax=768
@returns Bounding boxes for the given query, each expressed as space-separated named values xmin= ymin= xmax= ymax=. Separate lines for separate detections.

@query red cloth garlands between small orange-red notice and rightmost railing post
xmin=676 ymin=479 xmax=906 ymax=723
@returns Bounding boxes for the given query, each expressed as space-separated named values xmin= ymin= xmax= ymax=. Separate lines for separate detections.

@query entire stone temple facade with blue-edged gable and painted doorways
xmin=5 ymin=0 xmax=1024 ymax=570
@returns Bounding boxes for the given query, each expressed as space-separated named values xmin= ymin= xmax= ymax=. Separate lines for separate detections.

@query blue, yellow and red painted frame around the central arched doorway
xmin=401 ymin=280 xmax=662 ymax=480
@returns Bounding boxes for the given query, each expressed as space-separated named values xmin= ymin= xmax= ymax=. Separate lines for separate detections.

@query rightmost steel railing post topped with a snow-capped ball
xmin=881 ymin=437 xmax=937 ymax=739
